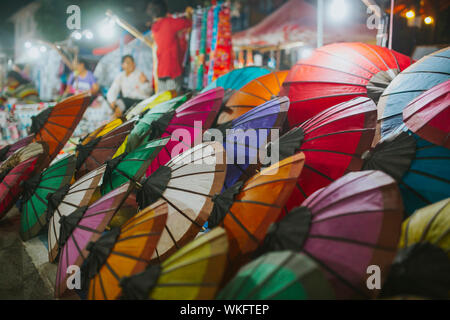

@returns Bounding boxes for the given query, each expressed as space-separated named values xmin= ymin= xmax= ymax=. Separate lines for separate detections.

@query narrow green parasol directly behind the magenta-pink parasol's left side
xmin=126 ymin=95 xmax=187 ymax=152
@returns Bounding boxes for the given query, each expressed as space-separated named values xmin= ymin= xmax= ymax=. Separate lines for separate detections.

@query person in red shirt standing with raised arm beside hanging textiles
xmin=147 ymin=0 xmax=192 ymax=92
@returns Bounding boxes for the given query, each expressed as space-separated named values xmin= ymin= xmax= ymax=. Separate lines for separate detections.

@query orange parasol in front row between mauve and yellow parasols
xmin=82 ymin=201 xmax=168 ymax=300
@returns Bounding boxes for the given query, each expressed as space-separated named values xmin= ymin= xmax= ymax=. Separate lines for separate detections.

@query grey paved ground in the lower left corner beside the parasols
xmin=0 ymin=208 xmax=56 ymax=299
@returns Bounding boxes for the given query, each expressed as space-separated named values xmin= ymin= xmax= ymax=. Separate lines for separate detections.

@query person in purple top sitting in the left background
xmin=64 ymin=59 xmax=99 ymax=96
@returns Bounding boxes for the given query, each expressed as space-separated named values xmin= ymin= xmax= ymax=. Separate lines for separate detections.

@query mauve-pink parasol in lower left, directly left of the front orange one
xmin=55 ymin=183 xmax=131 ymax=298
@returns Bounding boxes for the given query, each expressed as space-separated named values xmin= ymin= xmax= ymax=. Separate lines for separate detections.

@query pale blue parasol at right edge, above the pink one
xmin=377 ymin=47 xmax=450 ymax=138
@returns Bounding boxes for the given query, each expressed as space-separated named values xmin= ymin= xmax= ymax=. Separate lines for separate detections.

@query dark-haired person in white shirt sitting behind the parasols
xmin=106 ymin=55 xmax=152 ymax=117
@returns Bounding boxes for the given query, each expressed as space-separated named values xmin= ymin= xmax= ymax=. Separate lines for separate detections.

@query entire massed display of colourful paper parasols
xmin=0 ymin=43 xmax=450 ymax=299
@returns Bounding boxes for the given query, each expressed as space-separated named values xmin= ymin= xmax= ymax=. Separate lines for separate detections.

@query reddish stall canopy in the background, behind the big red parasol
xmin=233 ymin=0 xmax=377 ymax=47
